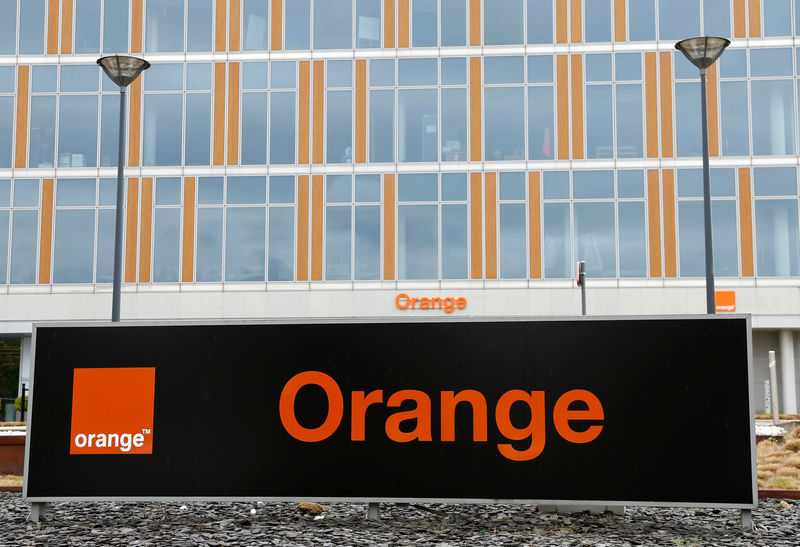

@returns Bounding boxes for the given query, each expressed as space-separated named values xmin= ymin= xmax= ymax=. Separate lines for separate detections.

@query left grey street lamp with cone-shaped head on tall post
xmin=97 ymin=55 xmax=150 ymax=322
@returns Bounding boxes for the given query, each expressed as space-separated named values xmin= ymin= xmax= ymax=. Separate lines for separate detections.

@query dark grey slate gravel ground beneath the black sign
xmin=0 ymin=494 xmax=800 ymax=547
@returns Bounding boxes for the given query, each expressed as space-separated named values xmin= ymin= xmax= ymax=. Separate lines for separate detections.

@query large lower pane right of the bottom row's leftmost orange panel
xmin=53 ymin=209 xmax=94 ymax=283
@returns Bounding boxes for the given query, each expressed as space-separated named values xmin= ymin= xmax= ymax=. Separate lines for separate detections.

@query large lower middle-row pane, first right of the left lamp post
xmin=142 ymin=94 xmax=183 ymax=165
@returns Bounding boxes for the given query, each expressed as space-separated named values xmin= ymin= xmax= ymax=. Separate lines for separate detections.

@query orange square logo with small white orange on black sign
xmin=69 ymin=367 xmax=156 ymax=454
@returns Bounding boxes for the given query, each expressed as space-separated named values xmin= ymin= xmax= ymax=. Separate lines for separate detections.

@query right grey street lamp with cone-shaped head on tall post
xmin=675 ymin=36 xmax=731 ymax=314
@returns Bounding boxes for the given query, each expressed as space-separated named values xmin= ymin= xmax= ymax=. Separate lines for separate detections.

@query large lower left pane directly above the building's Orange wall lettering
xmin=397 ymin=205 xmax=439 ymax=279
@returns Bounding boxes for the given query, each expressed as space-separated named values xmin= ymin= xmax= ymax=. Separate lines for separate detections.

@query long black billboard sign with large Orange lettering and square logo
xmin=25 ymin=316 xmax=756 ymax=508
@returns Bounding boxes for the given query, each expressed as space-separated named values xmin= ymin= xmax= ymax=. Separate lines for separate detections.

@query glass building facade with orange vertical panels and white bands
xmin=0 ymin=0 xmax=800 ymax=284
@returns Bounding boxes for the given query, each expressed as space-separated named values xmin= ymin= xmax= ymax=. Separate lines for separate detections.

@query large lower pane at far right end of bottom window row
xmin=756 ymin=199 xmax=800 ymax=277
